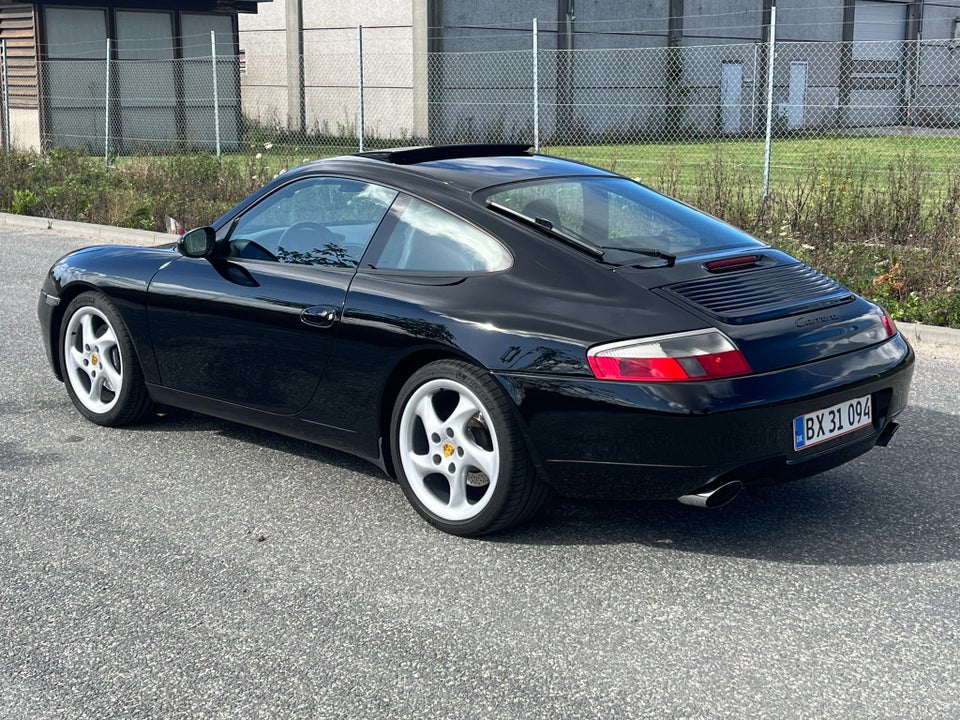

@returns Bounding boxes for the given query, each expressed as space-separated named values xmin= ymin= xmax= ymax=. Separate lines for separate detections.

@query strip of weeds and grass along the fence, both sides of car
xmin=0 ymin=144 xmax=960 ymax=328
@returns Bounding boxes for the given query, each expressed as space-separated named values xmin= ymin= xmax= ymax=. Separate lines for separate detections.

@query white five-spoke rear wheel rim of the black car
xmin=397 ymin=378 xmax=501 ymax=523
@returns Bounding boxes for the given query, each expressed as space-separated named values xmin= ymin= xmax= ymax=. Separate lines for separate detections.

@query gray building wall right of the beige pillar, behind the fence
xmin=430 ymin=0 xmax=960 ymax=142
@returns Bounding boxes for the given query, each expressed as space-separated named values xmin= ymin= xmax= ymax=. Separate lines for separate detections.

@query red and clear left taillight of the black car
xmin=587 ymin=330 xmax=751 ymax=382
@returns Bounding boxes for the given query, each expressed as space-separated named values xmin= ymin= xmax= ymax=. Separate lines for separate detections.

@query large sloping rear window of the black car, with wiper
xmin=484 ymin=176 xmax=763 ymax=263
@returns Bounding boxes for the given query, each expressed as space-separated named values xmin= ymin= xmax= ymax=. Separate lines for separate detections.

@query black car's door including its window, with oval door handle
xmin=148 ymin=176 xmax=396 ymax=415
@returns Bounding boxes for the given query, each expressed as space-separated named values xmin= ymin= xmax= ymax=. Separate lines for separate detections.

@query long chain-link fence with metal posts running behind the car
xmin=3 ymin=22 xmax=960 ymax=190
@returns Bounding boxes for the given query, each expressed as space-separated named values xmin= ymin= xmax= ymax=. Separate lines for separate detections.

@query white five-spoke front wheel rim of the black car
xmin=63 ymin=305 xmax=124 ymax=415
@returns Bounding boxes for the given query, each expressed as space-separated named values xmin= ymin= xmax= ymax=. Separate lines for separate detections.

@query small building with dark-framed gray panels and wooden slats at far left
xmin=0 ymin=0 xmax=269 ymax=152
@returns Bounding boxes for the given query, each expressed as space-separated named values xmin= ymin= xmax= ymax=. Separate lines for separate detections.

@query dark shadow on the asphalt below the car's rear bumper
xmin=490 ymin=408 xmax=960 ymax=565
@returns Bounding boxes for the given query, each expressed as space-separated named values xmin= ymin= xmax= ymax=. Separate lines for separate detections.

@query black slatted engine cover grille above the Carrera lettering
xmin=665 ymin=263 xmax=853 ymax=324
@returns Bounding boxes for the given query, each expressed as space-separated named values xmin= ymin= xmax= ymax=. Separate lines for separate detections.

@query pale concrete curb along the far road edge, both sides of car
xmin=0 ymin=213 xmax=960 ymax=347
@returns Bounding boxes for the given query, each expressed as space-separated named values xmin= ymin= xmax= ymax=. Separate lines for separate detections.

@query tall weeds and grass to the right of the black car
xmin=653 ymin=152 xmax=960 ymax=328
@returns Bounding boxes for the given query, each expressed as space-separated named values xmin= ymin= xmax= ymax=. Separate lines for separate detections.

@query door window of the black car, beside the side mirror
xmin=230 ymin=177 xmax=397 ymax=268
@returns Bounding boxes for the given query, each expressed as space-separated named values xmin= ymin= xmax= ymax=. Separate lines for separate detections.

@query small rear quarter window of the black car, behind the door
xmin=377 ymin=198 xmax=512 ymax=273
